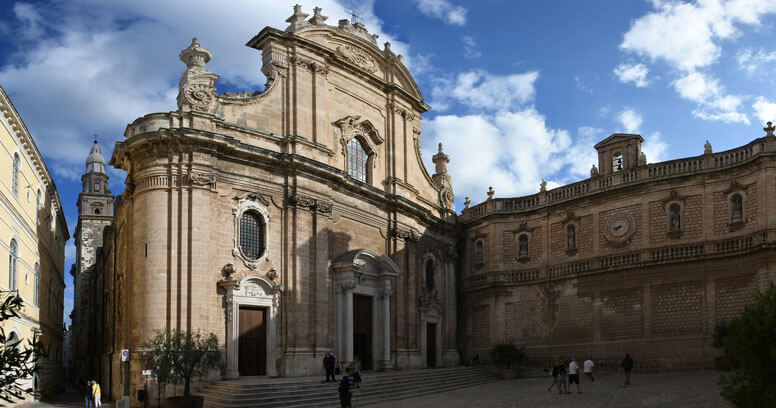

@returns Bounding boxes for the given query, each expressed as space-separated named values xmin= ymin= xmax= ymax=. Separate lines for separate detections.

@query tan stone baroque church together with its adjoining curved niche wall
xmin=73 ymin=6 xmax=776 ymax=404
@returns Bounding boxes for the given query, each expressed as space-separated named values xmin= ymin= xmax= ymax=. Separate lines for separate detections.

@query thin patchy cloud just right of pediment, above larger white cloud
xmin=431 ymin=70 xmax=539 ymax=110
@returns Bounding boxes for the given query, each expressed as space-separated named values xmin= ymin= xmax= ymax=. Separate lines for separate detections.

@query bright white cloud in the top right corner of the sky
xmin=615 ymin=0 xmax=776 ymax=123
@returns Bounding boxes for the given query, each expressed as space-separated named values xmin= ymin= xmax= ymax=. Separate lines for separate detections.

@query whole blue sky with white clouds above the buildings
xmin=0 ymin=0 xmax=776 ymax=326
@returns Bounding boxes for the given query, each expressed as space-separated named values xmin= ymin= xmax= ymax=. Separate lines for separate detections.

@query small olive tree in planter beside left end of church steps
xmin=146 ymin=330 xmax=221 ymax=398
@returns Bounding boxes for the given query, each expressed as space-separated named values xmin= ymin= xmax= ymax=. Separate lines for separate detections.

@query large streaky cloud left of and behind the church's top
xmin=0 ymin=0 xmax=412 ymax=170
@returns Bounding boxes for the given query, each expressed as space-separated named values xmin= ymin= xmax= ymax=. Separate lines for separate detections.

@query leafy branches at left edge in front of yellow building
xmin=0 ymin=296 xmax=44 ymax=395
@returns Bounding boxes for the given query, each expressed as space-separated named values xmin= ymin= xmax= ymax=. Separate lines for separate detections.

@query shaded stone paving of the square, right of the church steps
xmin=371 ymin=371 xmax=732 ymax=408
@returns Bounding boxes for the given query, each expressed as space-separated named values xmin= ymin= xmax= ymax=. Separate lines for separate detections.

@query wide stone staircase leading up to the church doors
xmin=199 ymin=367 xmax=499 ymax=408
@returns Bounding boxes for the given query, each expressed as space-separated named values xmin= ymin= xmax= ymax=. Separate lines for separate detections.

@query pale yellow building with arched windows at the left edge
xmin=0 ymin=87 xmax=70 ymax=404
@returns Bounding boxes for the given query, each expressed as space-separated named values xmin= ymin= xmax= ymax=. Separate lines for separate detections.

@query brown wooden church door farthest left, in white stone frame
xmin=237 ymin=306 xmax=267 ymax=376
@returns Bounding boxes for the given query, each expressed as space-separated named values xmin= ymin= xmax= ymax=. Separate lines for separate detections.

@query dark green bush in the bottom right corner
xmin=714 ymin=283 xmax=776 ymax=407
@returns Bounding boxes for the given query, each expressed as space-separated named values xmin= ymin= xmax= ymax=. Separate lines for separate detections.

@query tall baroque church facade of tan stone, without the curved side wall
xmin=82 ymin=7 xmax=459 ymax=403
